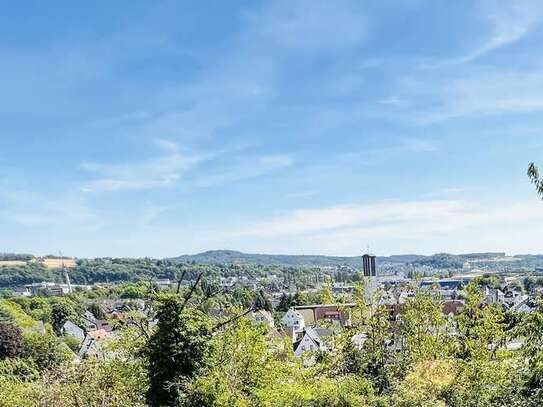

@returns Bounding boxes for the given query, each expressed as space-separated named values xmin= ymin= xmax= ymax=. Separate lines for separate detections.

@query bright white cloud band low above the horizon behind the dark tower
xmin=304 ymin=200 xmax=543 ymax=254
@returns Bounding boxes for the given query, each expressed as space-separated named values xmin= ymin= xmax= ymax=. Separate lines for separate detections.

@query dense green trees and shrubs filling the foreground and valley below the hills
xmin=0 ymin=276 xmax=543 ymax=407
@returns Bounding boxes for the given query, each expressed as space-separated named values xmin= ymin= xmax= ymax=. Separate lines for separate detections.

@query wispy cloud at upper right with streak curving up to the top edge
xmin=369 ymin=0 xmax=543 ymax=124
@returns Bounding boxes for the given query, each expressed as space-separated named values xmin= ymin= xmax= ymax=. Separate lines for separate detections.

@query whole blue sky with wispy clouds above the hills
xmin=0 ymin=0 xmax=543 ymax=257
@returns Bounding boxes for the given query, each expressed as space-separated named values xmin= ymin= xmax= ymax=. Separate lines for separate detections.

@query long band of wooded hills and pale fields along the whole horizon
xmin=0 ymin=250 xmax=543 ymax=288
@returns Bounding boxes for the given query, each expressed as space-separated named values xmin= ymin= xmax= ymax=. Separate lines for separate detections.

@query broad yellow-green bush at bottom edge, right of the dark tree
xmin=189 ymin=319 xmax=384 ymax=407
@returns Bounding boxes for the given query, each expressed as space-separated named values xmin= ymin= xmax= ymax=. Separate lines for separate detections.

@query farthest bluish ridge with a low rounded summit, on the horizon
xmin=172 ymin=250 xmax=436 ymax=267
